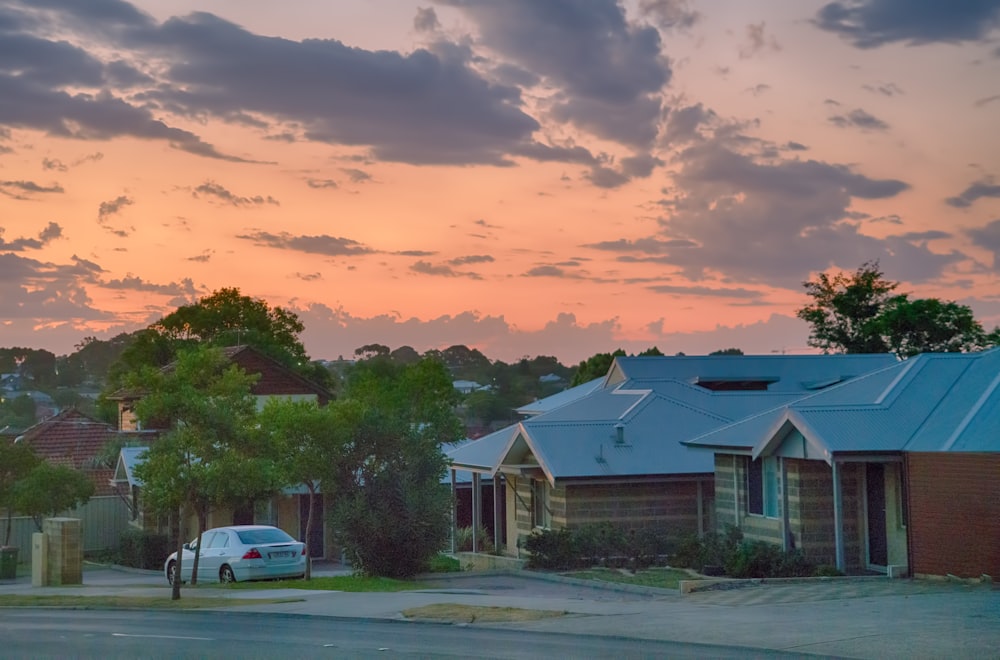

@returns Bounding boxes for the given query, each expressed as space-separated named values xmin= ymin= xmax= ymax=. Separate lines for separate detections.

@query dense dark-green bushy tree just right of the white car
xmin=332 ymin=358 xmax=463 ymax=577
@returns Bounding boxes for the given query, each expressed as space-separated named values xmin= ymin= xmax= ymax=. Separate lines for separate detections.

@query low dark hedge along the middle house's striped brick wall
xmin=525 ymin=522 xmax=671 ymax=569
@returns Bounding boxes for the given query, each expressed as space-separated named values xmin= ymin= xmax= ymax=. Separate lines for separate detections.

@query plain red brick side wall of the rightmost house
xmin=906 ymin=453 xmax=1000 ymax=579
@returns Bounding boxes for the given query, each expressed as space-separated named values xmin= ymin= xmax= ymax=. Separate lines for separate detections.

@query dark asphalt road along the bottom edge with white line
xmin=0 ymin=609 xmax=817 ymax=660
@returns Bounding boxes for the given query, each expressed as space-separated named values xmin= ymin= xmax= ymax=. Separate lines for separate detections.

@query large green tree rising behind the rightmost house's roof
xmin=797 ymin=261 xmax=1000 ymax=358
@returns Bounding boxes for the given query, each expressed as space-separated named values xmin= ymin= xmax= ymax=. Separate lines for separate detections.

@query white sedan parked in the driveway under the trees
xmin=163 ymin=525 xmax=306 ymax=584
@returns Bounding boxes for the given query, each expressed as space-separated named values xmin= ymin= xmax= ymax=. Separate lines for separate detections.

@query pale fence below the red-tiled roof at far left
xmin=0 ymin=496 xmax=128 ymax=562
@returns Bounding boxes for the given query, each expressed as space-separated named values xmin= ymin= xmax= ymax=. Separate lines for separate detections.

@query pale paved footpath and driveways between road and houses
xmin=0 ymin=564 xmax=1000 ymax=660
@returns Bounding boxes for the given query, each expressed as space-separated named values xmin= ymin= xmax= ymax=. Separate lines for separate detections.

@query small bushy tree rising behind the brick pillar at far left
xmin=12 ymin=461 xmax=94 ymax=531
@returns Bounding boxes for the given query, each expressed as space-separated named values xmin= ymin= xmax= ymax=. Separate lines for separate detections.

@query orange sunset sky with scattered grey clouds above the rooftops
xmin=0 ymin=0 xmax=1000 ymax=364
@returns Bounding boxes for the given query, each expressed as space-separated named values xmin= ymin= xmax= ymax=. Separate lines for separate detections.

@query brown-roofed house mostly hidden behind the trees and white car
xmin=108 ymin=346 xmax=335 ymax=557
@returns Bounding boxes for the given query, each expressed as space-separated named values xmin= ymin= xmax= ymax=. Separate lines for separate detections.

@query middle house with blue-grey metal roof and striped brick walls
xmin=449 ymin=355 xmax=896 ymax=555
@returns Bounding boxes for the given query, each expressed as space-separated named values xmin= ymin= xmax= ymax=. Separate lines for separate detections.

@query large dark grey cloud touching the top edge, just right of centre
xmin=445 ymin=0 xmax=671 ymax=150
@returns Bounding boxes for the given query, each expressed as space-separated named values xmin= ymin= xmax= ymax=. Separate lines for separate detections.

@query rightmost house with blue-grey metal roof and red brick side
xmin=687 ymin=349 xmax=1000 ymax=577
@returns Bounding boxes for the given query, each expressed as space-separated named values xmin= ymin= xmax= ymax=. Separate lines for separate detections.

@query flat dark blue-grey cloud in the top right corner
xmin=813 ymin=0 xmax=1000 ymax=48
